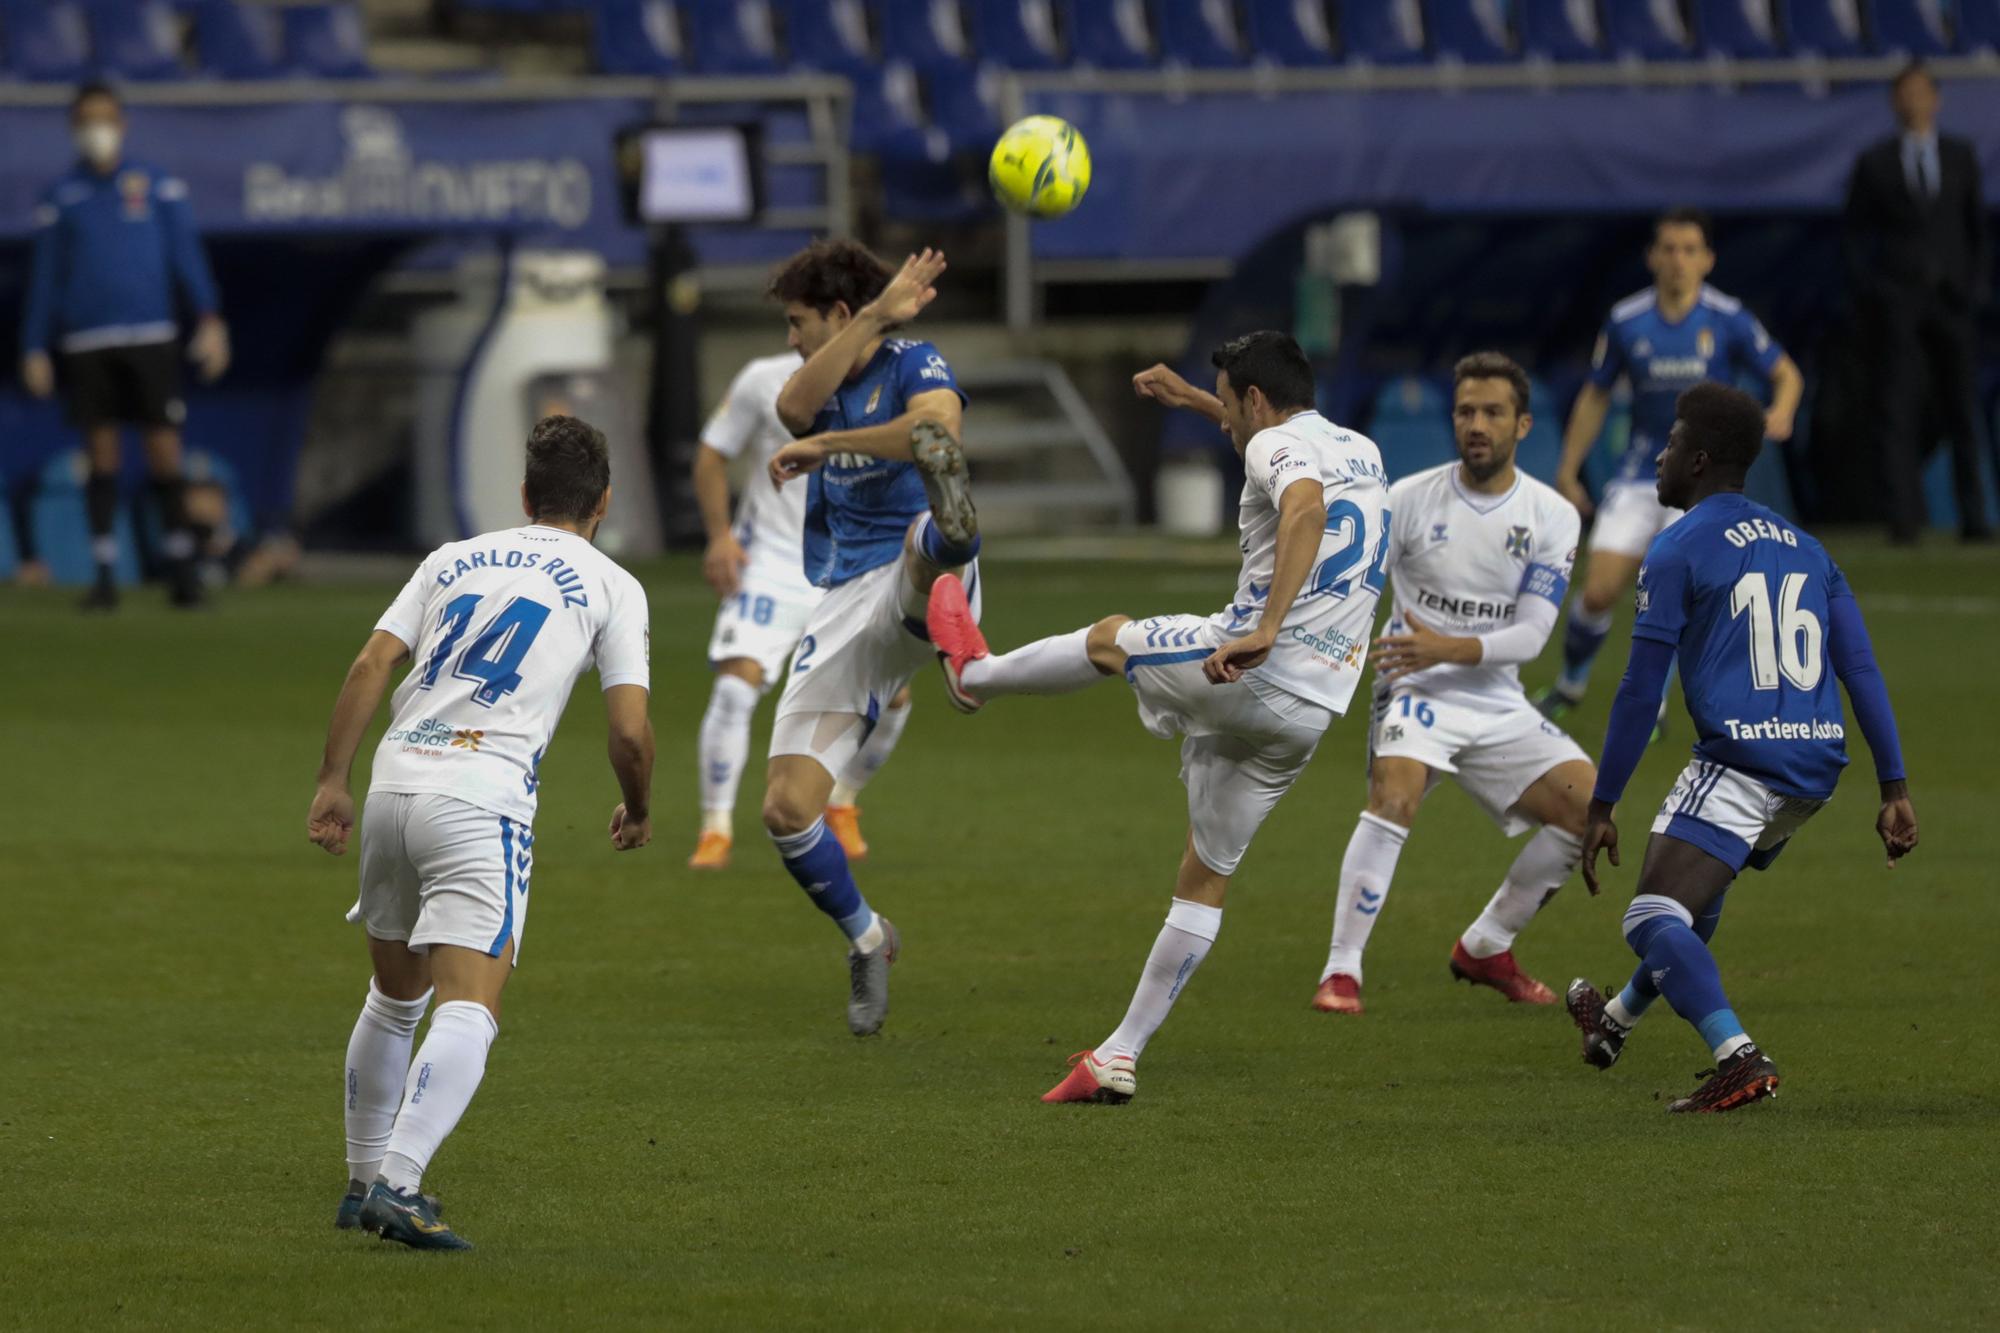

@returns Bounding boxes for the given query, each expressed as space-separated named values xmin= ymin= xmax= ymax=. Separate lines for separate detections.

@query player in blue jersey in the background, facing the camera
xmin=1536 ymin=208 xmax=1806 ymax=721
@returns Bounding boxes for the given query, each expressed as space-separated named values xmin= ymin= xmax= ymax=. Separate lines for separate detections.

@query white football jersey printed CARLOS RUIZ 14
xmin=370 ymin=524 xmax=650 ymax=825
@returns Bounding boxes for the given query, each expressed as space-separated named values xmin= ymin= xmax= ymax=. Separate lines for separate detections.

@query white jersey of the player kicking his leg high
xmin=1210 ymin=412 xmax=1390 ymax=713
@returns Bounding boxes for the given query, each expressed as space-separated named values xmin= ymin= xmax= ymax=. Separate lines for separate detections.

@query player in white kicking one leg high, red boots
xmin=930 ymin=332 xmax=1390 ymax=1103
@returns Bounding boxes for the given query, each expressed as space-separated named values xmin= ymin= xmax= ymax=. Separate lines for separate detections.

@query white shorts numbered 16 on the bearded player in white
xmin=1368 ymin=685 xmax=1590 ymax=839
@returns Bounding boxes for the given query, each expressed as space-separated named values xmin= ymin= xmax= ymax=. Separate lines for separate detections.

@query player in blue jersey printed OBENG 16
xmin=1568 ymin=384 xmax=1916 ymax=1111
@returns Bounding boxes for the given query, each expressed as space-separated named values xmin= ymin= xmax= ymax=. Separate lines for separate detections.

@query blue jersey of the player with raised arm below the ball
xmin=806 ymin=338 xmax=966 ymax=588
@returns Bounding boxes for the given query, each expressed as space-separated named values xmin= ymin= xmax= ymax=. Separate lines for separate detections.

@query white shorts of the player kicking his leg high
xmin=1118 ymin=616 xmax=1334 ymax=875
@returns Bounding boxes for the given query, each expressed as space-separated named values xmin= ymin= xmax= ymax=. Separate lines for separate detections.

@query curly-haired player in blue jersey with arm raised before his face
xmin=764 ymin=240 xmax=980 ymax=1037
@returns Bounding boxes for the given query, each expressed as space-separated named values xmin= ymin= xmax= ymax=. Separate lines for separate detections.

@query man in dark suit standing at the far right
xmin=1842 ymin=64 xmax=1992 ymax=542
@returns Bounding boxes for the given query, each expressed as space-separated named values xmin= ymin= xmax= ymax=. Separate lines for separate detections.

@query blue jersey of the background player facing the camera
xmin=1590 ymin=284 xmax=1784 ymax=480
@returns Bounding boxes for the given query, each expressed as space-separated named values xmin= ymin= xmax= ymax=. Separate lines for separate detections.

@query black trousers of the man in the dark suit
xmin=1868 ymin=290 xmax=1988 ymax=540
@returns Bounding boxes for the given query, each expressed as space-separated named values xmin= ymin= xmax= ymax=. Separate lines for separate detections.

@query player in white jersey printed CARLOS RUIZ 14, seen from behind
xmin=306 ymin=416 xmax=652 ymax=1249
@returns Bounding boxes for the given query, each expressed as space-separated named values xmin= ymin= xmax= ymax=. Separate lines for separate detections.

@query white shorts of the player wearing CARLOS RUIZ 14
xmin=348 ymin=791 xmax=534 ymax=963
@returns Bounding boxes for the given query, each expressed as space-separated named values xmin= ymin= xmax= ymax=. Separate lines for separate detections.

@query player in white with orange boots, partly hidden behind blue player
xmin=688 ymin=352 xmax=910 ymax=871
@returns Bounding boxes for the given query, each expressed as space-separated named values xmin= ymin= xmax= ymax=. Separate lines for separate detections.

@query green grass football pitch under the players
xmin=0 ymin=538 xmax=2000 ymax=1329
